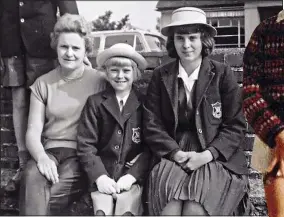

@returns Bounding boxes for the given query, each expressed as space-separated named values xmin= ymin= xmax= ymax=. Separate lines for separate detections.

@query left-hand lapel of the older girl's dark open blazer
xmin=161 ymin=60 xmax=178 ymax=129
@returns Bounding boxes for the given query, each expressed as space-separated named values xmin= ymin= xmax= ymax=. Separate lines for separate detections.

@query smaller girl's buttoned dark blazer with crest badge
xmin=77 ymin=85 xmax=150 ymax=188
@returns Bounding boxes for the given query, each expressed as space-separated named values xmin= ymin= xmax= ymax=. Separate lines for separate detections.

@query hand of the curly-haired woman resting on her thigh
xmin=37 ymin=153 xmax=59 ymax=184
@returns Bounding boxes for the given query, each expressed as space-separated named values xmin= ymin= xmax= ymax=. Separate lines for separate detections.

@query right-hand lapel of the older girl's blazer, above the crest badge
xmin=194 ymin=57 xmax=215 ymax=108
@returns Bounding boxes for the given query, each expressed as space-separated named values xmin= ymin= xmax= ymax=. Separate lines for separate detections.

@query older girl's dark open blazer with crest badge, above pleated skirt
xmin=143 ymin=57 xmax=248 ymax=174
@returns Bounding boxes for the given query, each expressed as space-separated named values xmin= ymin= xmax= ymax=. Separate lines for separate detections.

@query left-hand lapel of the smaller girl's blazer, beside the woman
xmin=102 ymin=86 xmax=123 ymax=127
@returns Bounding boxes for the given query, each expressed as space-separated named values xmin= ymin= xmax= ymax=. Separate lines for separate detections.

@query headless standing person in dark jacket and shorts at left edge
xmin=0 ymin=0 xmax=78 ymax=191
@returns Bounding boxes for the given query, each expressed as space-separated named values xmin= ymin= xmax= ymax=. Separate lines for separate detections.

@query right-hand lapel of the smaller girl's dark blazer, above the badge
xmin=121 ymin=88 xmax=141 ymax=125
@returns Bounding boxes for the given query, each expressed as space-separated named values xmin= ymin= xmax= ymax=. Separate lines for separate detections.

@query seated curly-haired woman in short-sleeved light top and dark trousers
xmin=20 ymin=14 xmax=104 ymax=215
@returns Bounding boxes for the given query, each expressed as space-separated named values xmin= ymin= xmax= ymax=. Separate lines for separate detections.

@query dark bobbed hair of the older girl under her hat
xmin=166 ymin=24 xmax=215 ymax=58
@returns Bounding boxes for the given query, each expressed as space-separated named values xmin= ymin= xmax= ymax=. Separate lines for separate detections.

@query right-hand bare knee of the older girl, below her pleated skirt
xmin=182 ymin=201 xmax=208 ymax=216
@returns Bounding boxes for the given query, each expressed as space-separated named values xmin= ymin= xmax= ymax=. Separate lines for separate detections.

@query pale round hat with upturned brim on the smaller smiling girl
xmin=97 ymin=43 xmax=147 ymax=70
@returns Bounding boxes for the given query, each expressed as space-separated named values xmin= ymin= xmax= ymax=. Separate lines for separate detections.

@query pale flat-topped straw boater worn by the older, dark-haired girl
xmin=161 ymin=7 xmax=217 ymax=37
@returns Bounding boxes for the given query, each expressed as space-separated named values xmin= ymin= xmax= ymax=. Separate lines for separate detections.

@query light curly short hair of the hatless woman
xmin=50 ymin=13 xmax=93 ymax=54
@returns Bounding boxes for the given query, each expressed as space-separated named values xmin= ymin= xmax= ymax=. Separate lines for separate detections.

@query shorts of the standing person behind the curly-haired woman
xmin=2 ymin=55 xmax=57 ymax=87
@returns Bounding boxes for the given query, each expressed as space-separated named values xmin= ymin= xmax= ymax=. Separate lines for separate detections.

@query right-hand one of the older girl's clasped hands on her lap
xmin=182 ymin=150 xmax=213 ymax=171
